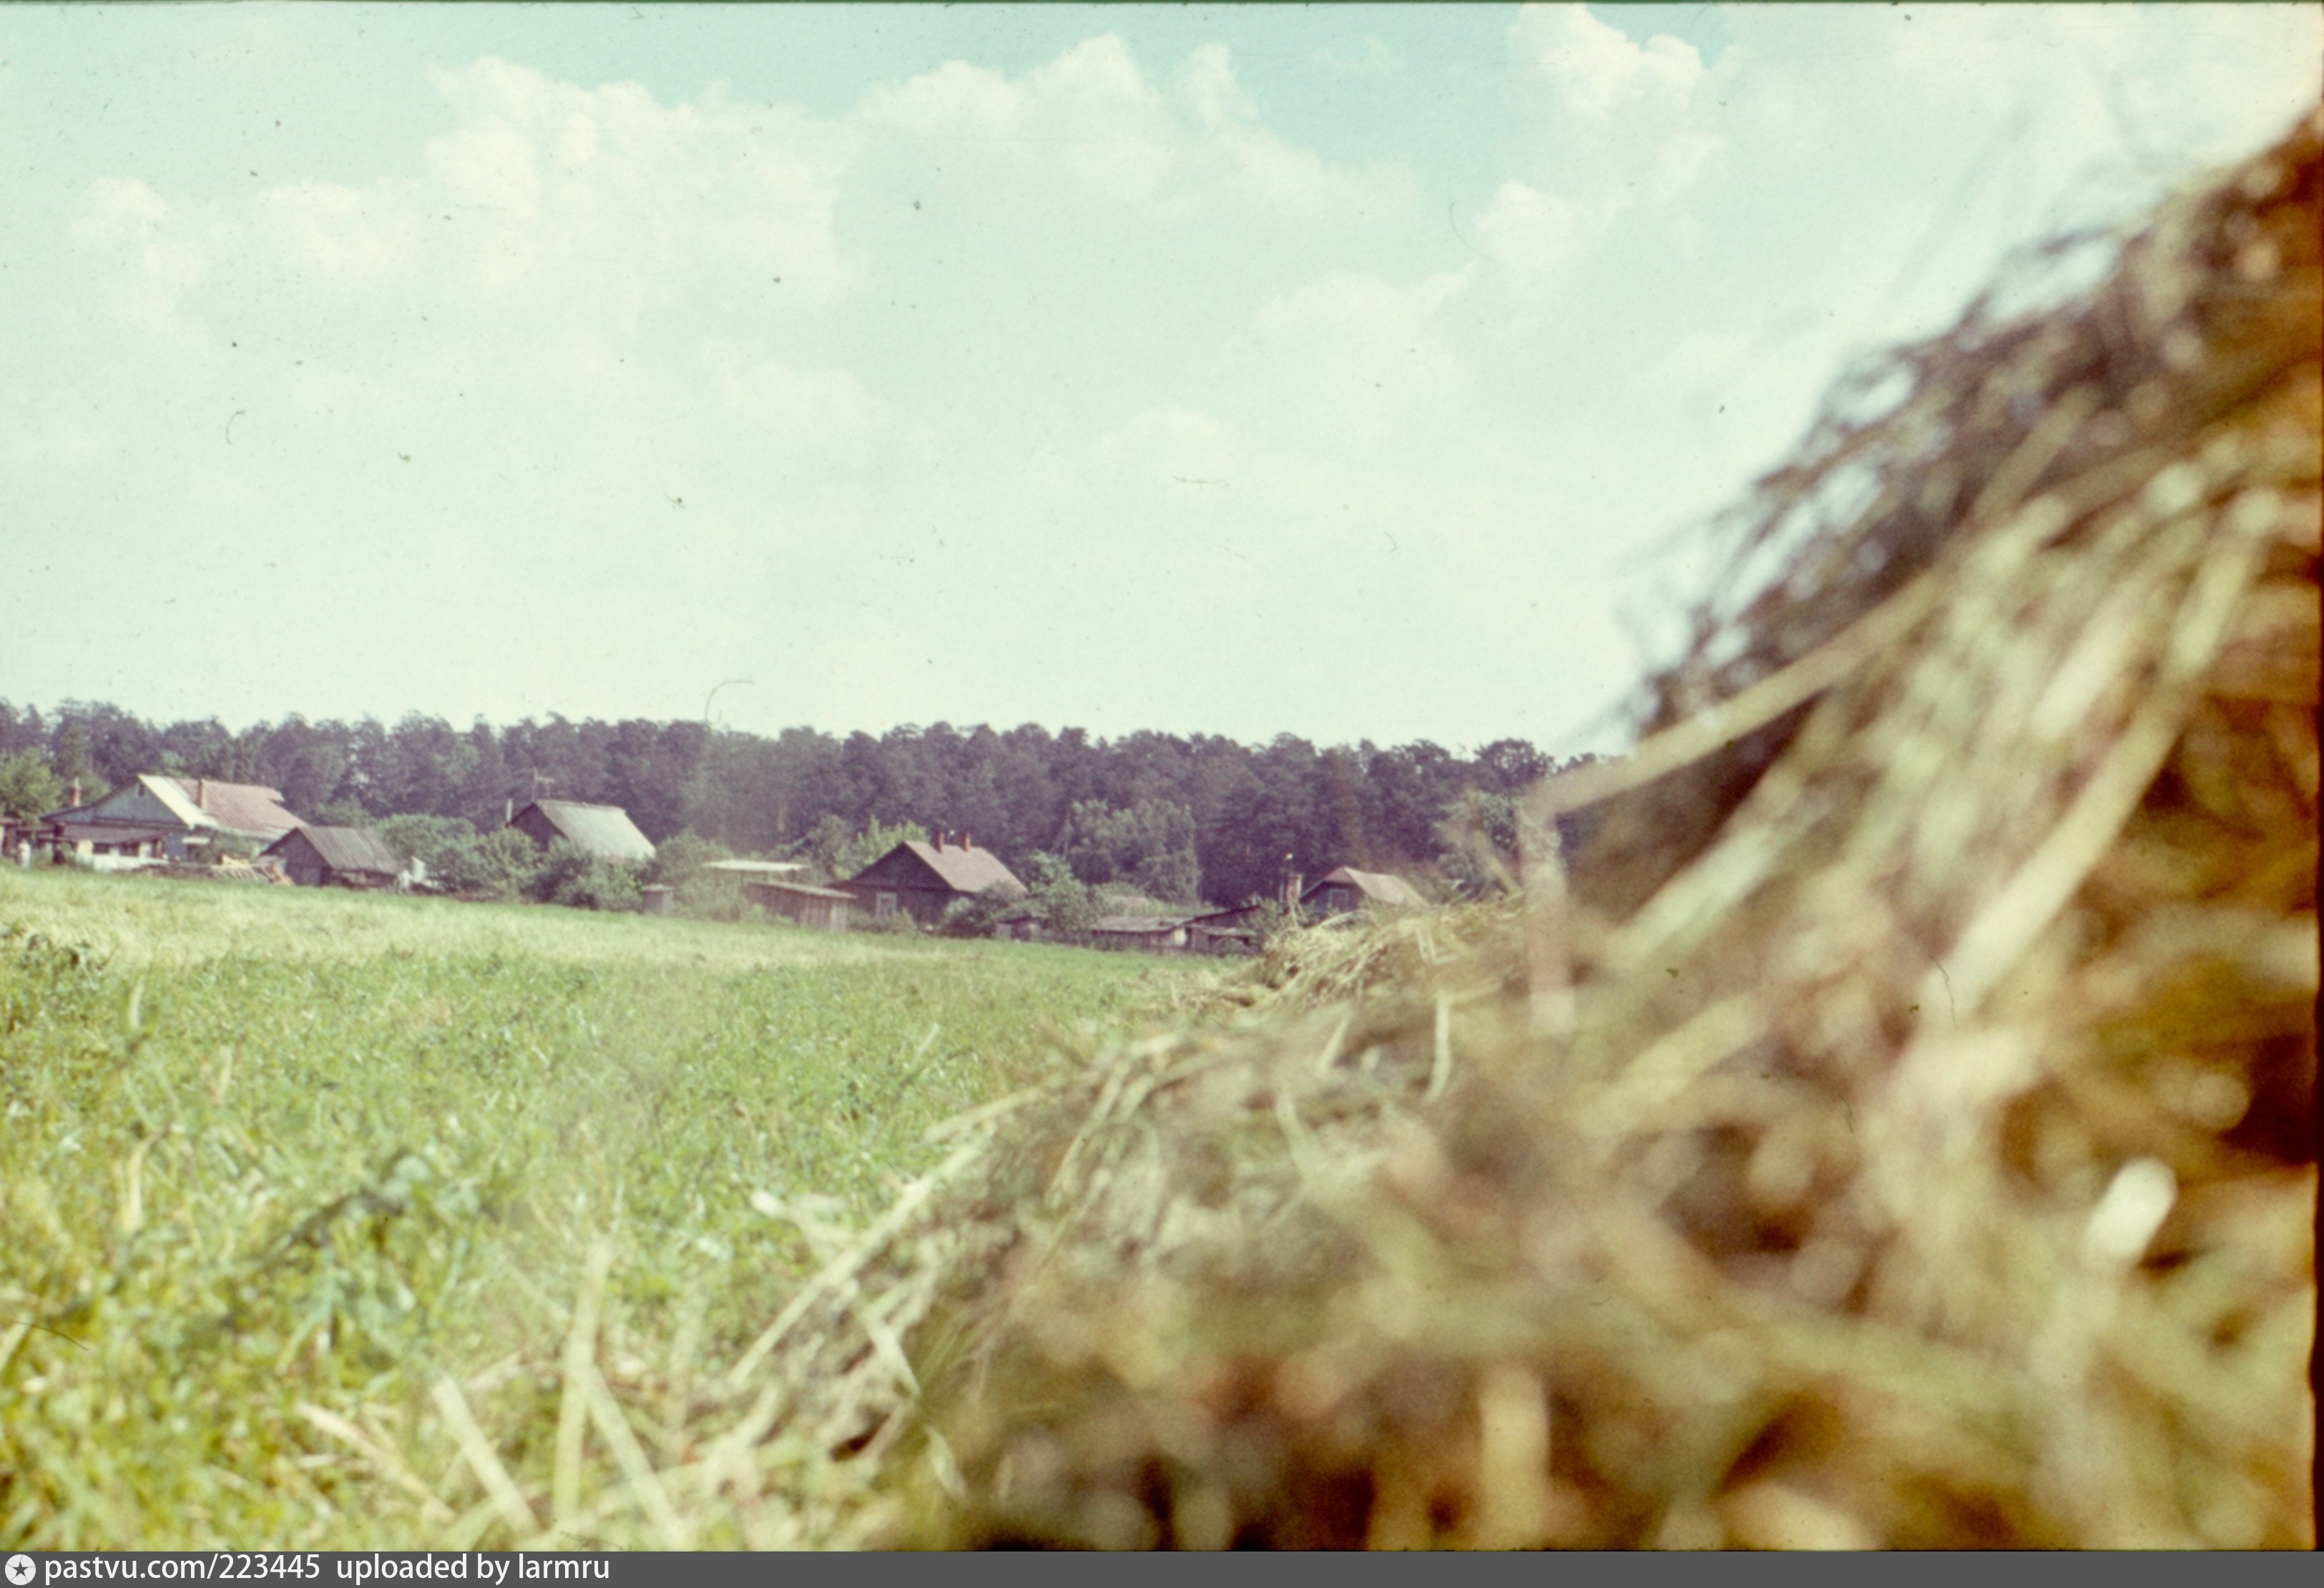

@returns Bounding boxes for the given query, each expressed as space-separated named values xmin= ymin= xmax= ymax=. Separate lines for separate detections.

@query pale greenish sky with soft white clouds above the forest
xmin=0 ymin=5 xmax=2324 ymax=753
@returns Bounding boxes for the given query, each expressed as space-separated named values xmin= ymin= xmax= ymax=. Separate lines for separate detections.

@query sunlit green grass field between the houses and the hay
xmin=0 ymin=867 xmax=1217 ymax=1549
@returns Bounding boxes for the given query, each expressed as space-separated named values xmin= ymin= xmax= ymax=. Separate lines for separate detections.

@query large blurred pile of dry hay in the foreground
xmin=553 ymin=117 xmax=2324 ymax=1546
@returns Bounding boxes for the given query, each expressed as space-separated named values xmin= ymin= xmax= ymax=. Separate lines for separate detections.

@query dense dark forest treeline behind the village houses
xmin=0 ymin=700 xmax=1574 ymax=904
